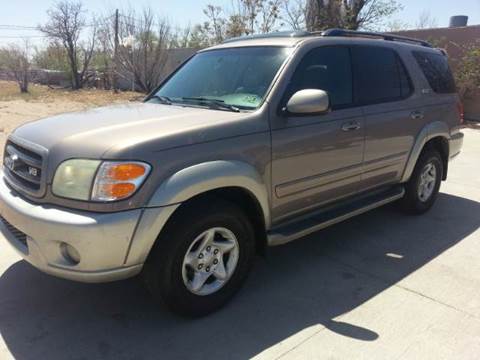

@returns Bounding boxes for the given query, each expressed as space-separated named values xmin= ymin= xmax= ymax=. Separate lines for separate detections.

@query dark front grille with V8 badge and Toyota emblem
xmin=3 ymin=139 xmax=43 ymax=196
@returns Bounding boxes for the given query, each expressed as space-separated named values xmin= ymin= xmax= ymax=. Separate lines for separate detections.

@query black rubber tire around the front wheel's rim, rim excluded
xmin=142 ymin=198 xmax=255 ymax=317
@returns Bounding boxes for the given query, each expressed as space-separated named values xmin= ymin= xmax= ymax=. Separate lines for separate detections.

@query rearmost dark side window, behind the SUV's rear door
xmin=413 ymin=51 xmax=456 ymax=94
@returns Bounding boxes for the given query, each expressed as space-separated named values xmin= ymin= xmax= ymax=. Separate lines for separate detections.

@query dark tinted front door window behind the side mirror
xmin=287 ymin=47 xmax=353 ymax=108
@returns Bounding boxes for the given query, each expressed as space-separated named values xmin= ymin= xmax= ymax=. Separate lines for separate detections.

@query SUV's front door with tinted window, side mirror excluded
xmin=272 ymin=46 xmax=364 ymax=223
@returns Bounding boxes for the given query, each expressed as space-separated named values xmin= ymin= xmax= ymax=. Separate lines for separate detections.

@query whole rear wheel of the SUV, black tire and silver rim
xmin=401 ymin=149 xmax=443 ymax=214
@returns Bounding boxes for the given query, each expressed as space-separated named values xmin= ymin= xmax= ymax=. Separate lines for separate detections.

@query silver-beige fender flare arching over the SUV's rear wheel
xmin=401 ymin=121 xmax=450 ymax=183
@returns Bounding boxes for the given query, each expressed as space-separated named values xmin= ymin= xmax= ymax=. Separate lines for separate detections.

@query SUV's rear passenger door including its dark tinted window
xmin=352 ymin=45 xmax=424 ymax=191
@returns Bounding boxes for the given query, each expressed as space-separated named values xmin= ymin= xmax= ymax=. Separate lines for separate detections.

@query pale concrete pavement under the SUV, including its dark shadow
xmin=0 ymin=130 xmax=480 ymax=359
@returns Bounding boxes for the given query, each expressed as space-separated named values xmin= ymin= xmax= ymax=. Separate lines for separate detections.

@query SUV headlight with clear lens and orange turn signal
xmin=52 ymin=159 xmax=150 ymax=202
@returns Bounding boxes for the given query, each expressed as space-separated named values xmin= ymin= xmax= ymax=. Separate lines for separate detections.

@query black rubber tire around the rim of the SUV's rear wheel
xmin=400 ymin=148 xmax=443 ymax=215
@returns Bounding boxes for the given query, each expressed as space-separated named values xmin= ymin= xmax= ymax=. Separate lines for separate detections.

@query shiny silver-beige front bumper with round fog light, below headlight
xmin=0 ymin=171 xmax=143 ymax=282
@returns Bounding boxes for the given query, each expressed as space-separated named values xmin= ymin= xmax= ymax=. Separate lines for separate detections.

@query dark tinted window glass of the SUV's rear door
xmin=352 ymin=46 xmax=413 ymax=104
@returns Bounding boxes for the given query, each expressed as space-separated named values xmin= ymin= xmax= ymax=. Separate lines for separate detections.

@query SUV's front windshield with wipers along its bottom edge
xmin=151 ymin=47 xmax=291 ymax=111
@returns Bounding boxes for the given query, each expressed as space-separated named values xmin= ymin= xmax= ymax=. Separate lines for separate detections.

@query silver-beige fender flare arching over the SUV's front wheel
xmin=147 ymin=160 xmax=271 ymax=229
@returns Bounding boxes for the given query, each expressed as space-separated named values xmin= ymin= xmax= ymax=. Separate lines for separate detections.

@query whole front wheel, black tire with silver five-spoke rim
xmin=142 ymin=198 xmax=255 ymax=317
